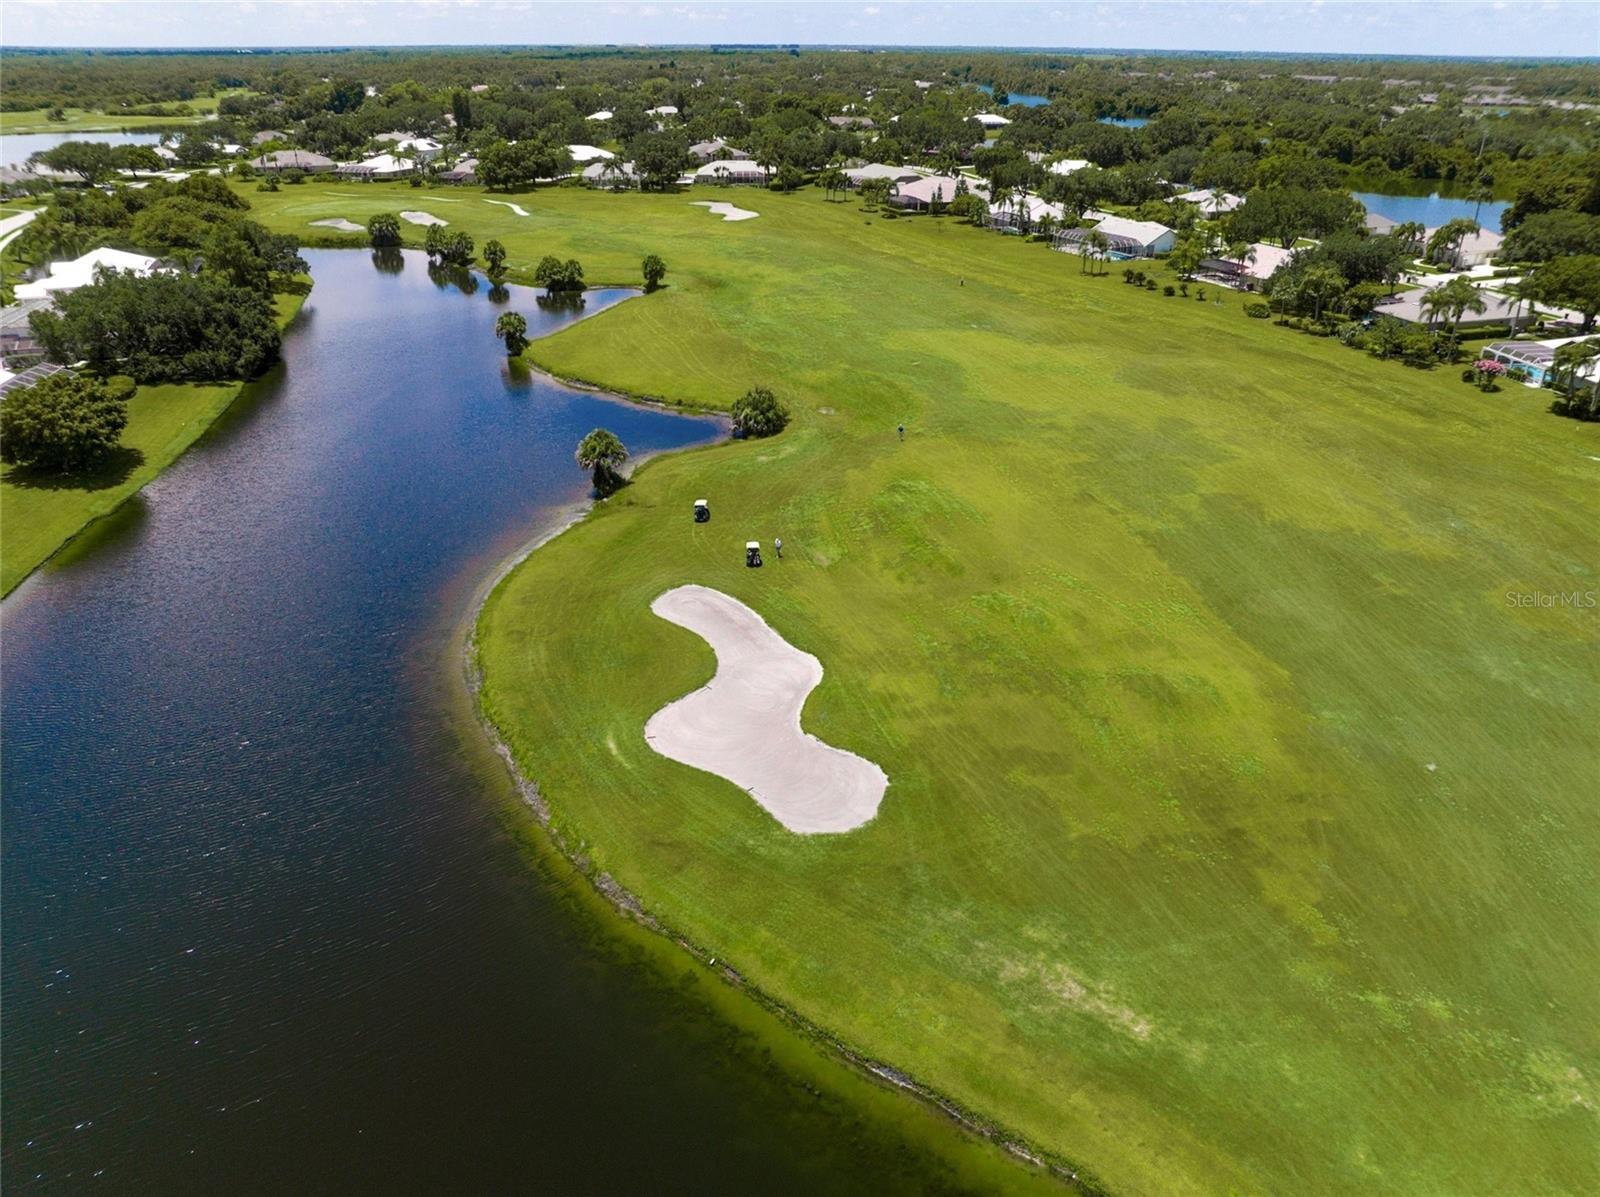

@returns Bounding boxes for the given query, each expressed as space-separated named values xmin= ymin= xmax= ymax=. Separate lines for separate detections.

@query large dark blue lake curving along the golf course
xmin=0 ymin=250 xmax=1024 ymax=1194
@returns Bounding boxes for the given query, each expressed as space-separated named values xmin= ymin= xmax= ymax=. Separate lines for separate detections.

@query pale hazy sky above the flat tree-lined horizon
xmin=0 ymin=0 xmax=1600 ymax=58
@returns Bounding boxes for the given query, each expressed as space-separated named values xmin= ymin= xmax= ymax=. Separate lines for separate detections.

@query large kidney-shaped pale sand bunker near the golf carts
xmin=645 ymin=586 xmax=890 ymax=832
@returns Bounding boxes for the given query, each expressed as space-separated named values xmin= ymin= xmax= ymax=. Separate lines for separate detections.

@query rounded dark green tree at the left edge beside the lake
xmin=0 ymin=370 xmax=131 ymax=474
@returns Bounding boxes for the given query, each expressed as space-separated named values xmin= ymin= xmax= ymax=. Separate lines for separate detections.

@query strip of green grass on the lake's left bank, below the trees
xmin=0 ymin=286 xmax=306 ymax=595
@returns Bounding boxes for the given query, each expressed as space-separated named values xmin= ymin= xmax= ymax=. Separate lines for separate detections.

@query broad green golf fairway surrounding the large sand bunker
xmin=251 ymin=184 xmax=1600 ymax=1195
